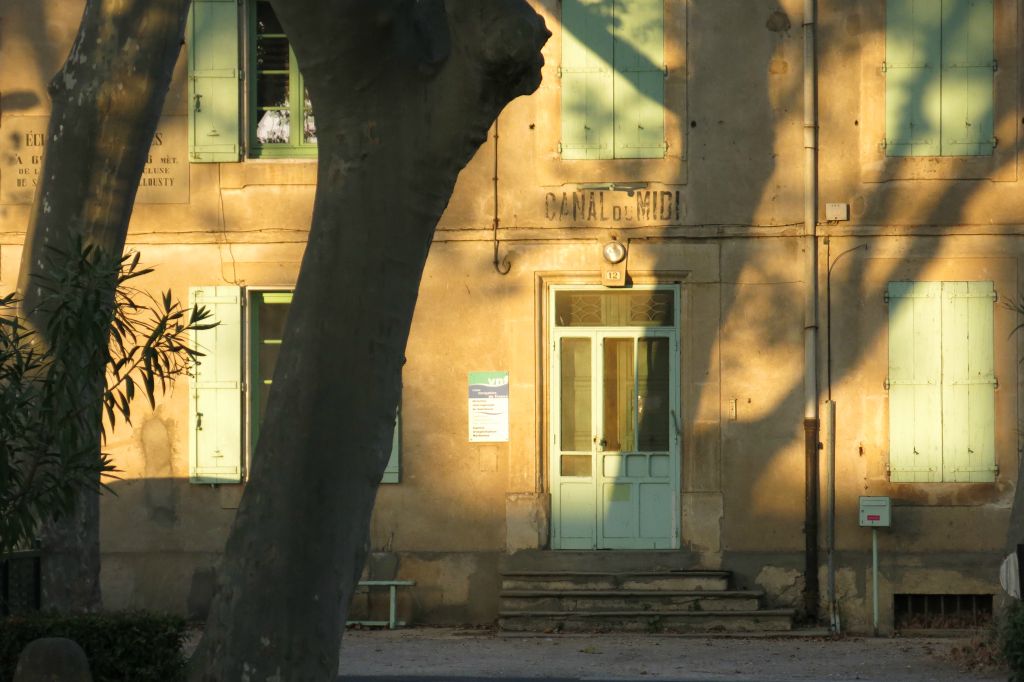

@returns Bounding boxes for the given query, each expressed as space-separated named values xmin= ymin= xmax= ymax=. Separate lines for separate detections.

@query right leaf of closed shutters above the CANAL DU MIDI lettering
xmin=613 ymin=0 xmax=666 ymax=159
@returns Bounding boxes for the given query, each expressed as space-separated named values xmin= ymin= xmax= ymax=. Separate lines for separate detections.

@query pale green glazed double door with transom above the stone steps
xmin=550 ymin=289 xmax=681 ymax=549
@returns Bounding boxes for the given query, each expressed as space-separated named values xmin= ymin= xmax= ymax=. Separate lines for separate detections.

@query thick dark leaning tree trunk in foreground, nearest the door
xmin=191 ymin=0 xmax=549 ymax=682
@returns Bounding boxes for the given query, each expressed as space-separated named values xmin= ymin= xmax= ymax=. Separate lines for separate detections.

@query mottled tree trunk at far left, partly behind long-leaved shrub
xmin=18 ymin=0 xmax=190 ymax=610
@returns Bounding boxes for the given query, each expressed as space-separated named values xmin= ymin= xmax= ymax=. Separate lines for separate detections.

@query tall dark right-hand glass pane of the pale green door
xmin=637 ymin=338 xmax=672 ymax=451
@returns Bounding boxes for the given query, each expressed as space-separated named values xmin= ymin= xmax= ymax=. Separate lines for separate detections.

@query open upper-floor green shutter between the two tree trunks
xmin=185 ymin=0 xmax=242 ymax=163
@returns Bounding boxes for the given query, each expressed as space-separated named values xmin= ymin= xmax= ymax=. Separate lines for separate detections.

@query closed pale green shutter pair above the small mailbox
xmin=887 ymin=282 xmax=996 ymax=482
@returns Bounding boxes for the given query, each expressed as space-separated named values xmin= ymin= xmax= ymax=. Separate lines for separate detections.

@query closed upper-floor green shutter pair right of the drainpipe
xmin=884 ymin=0 xmax=995 ymax=157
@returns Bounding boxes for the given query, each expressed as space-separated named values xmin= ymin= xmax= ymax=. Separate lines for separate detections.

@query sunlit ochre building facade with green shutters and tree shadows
xmin=0 ymin=0 xmax=1024 ymax=632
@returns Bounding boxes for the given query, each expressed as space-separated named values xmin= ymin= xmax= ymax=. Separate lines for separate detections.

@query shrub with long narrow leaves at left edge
xmin=0 ymin=247 xmax=213 ymax=554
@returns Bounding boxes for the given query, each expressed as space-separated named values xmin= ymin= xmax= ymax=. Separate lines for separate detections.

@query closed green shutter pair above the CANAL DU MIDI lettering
xmin=559 ymin=0 xmax=667 ymax=159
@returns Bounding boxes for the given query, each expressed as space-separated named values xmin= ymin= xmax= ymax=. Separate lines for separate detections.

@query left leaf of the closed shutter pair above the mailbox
xmin=888 ymin=282 xmax=942 ymax=482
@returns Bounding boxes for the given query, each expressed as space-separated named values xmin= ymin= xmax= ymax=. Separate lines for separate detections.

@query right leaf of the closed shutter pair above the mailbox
xmin=942 ymin=282 xmax=995 ymax=482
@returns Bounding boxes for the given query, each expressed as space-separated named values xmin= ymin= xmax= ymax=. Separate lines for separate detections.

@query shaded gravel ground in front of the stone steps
xmin=340 ymin=628 xmax=1008 ymax=682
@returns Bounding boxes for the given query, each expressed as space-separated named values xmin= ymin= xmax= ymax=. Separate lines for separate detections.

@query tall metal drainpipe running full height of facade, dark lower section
xmin=804 ymin=0 xmax=820 ymax=621
